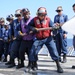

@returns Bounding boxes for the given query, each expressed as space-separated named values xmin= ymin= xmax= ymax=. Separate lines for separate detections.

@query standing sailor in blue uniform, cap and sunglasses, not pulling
xmin=54 ymin=6 xmax=68 ymax=63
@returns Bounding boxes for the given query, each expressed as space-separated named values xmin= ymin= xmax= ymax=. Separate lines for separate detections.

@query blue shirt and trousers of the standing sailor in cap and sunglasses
xmin=54 ymin=14 xmax=68 ymax=56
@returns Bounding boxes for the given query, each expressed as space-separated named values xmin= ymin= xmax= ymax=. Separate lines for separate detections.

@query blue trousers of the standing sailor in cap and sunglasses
xmin=55 ymin=33 xmax=67 ymax=56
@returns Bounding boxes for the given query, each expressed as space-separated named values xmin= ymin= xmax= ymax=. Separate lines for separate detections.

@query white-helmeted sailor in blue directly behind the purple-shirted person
xmin=8 ymin=9 xmax=22 ymax=68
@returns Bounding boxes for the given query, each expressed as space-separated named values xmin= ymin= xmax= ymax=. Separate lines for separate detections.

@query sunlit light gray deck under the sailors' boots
xmin=0 ymin=55 xmax=75 ymax=75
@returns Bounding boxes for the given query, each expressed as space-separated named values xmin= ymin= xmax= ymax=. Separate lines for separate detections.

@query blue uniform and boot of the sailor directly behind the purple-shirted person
xmin=8 ymin=19 xmax=21 ymax=68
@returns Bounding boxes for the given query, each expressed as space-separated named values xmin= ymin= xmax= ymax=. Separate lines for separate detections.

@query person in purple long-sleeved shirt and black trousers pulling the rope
xmin=17 ymin=8 xmax=34 ymax=69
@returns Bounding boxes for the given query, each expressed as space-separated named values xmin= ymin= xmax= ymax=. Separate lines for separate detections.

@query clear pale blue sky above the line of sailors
xmin=0 ymin=0 xmax=75 ymax=38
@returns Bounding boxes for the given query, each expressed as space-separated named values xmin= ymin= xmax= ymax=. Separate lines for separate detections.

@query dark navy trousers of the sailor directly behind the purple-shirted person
xmin=10 ymin=40 xmax=21 ymax=59
